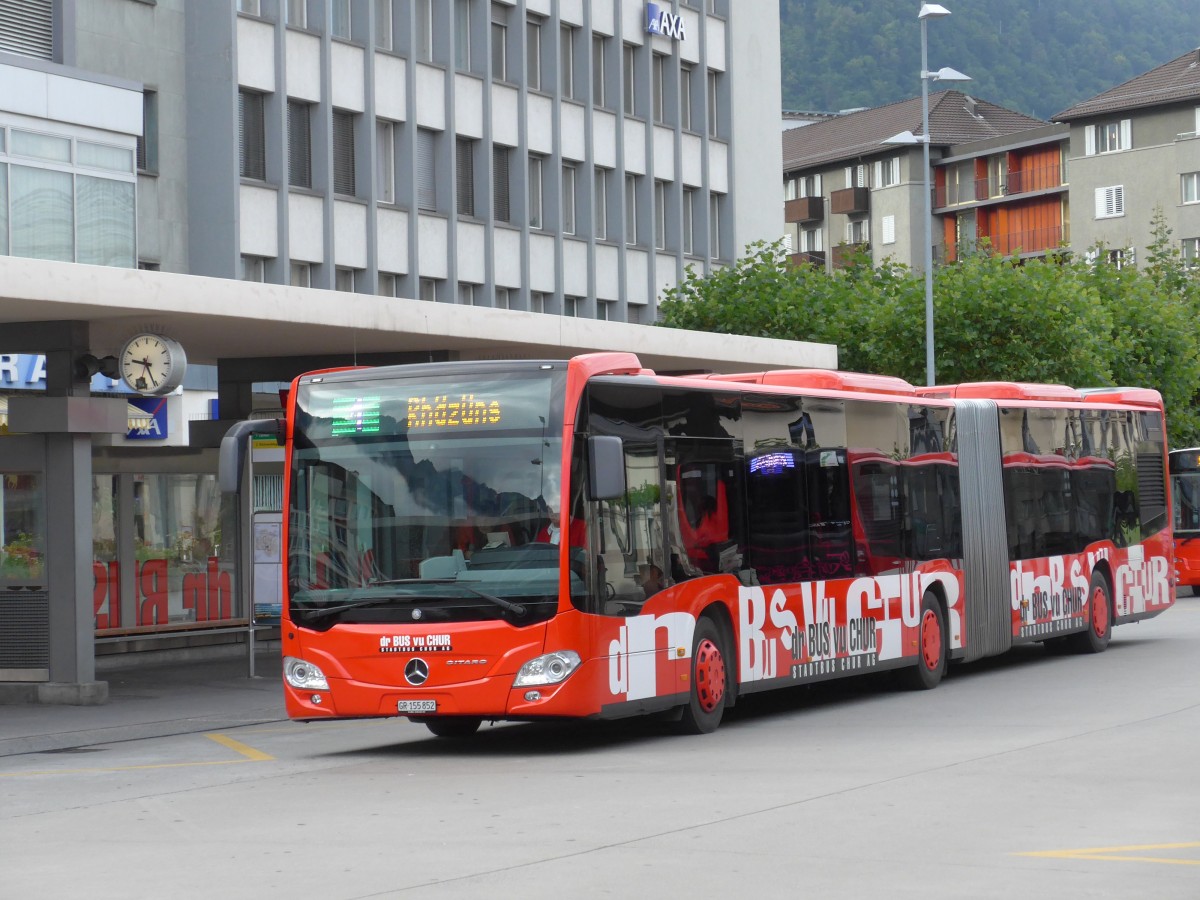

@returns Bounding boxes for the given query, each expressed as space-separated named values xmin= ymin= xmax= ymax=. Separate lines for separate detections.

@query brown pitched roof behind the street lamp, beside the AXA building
xmin=784 ymin=90 xmax=1046 ymax=169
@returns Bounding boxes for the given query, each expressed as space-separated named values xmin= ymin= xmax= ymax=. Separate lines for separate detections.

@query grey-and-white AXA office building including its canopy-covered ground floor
xmin=0 ymin=0 xmax=836 ymax=702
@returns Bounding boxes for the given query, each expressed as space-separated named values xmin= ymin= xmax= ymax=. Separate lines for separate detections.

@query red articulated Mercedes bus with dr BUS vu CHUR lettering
xmin=222 ymin=353 xmax=1175 ymax=737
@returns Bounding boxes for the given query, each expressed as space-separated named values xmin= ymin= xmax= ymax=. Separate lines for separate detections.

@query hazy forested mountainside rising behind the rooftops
xmin=779 ymin=0 xmax=1196 ymax=119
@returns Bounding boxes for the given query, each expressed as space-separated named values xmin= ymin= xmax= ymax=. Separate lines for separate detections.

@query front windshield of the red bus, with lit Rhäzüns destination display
xmin=288 ymin=370 xmax=571 ymax=628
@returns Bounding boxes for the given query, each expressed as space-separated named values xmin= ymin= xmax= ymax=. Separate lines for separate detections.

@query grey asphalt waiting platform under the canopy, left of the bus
xmin=0 ymin=648 xmax=287 ymax=757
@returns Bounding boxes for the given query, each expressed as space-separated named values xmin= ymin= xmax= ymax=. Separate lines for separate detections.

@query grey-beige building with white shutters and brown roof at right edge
xmin=1055 ymin=50 xmax=1200 ymax=270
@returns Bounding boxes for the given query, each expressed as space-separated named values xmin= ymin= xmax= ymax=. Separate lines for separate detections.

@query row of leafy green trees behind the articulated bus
xmin=659 ymin=230 xmax=1200 ymax=446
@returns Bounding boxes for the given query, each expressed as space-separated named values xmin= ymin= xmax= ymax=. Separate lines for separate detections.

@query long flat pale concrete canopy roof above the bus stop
xmin=0 ymin=257 xmax=838 ymax=372
